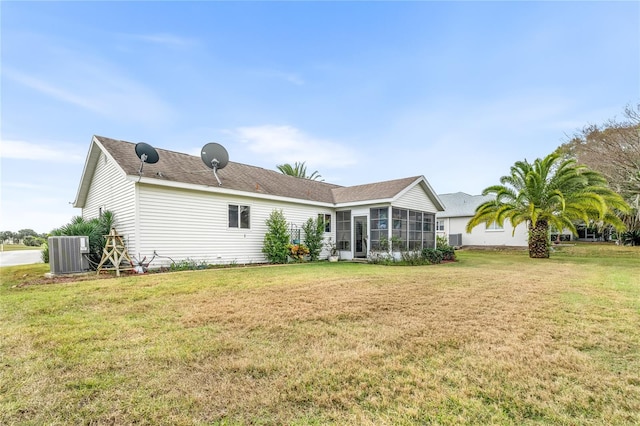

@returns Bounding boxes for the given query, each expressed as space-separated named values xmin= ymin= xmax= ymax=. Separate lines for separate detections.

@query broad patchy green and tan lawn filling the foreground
xmin=0 ymin=245 xmax=640 ymax=425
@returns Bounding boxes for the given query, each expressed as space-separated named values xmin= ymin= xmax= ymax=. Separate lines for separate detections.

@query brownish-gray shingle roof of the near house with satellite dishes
xmin=94 ymin=136 xmax=421 ymax=204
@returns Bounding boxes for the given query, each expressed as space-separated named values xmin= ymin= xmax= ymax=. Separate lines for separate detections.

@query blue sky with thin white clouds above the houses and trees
xmin=0 ymin=1 xmax=640 ymax=232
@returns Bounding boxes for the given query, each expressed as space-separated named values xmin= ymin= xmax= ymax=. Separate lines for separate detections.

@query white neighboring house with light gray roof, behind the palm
xmin=436 ymin=192 xmax=528 ymax=247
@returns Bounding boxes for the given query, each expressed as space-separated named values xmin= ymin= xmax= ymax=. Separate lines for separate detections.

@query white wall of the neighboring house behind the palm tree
xmin=437 ymin=217 xmax=528 ymax=247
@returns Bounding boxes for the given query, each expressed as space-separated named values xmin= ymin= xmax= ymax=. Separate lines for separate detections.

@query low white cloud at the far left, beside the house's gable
xmin=0 ymin=140 xmax=85 ymax=165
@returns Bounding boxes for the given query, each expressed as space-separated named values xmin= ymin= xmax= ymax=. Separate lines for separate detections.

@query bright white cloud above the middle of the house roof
xmin=232 ymin=125 xmax=357 ymax=170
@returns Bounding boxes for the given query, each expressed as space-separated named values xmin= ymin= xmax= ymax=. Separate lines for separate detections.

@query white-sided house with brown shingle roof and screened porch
xmin=74 ymin=136 xmax=444 ymax=266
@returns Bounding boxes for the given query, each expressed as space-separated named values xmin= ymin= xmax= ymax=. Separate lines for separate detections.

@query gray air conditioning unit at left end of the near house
xmin=49 ymin=236 xmax=89 ymax=275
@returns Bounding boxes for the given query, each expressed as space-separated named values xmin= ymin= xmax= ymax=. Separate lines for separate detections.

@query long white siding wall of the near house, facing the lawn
xmin=137 ymin=185 xmax=335 ymax=266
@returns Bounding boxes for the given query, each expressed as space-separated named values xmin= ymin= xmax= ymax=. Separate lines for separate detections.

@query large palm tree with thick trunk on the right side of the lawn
xmin=467 ymin=153 xmax=629 ymax=258
